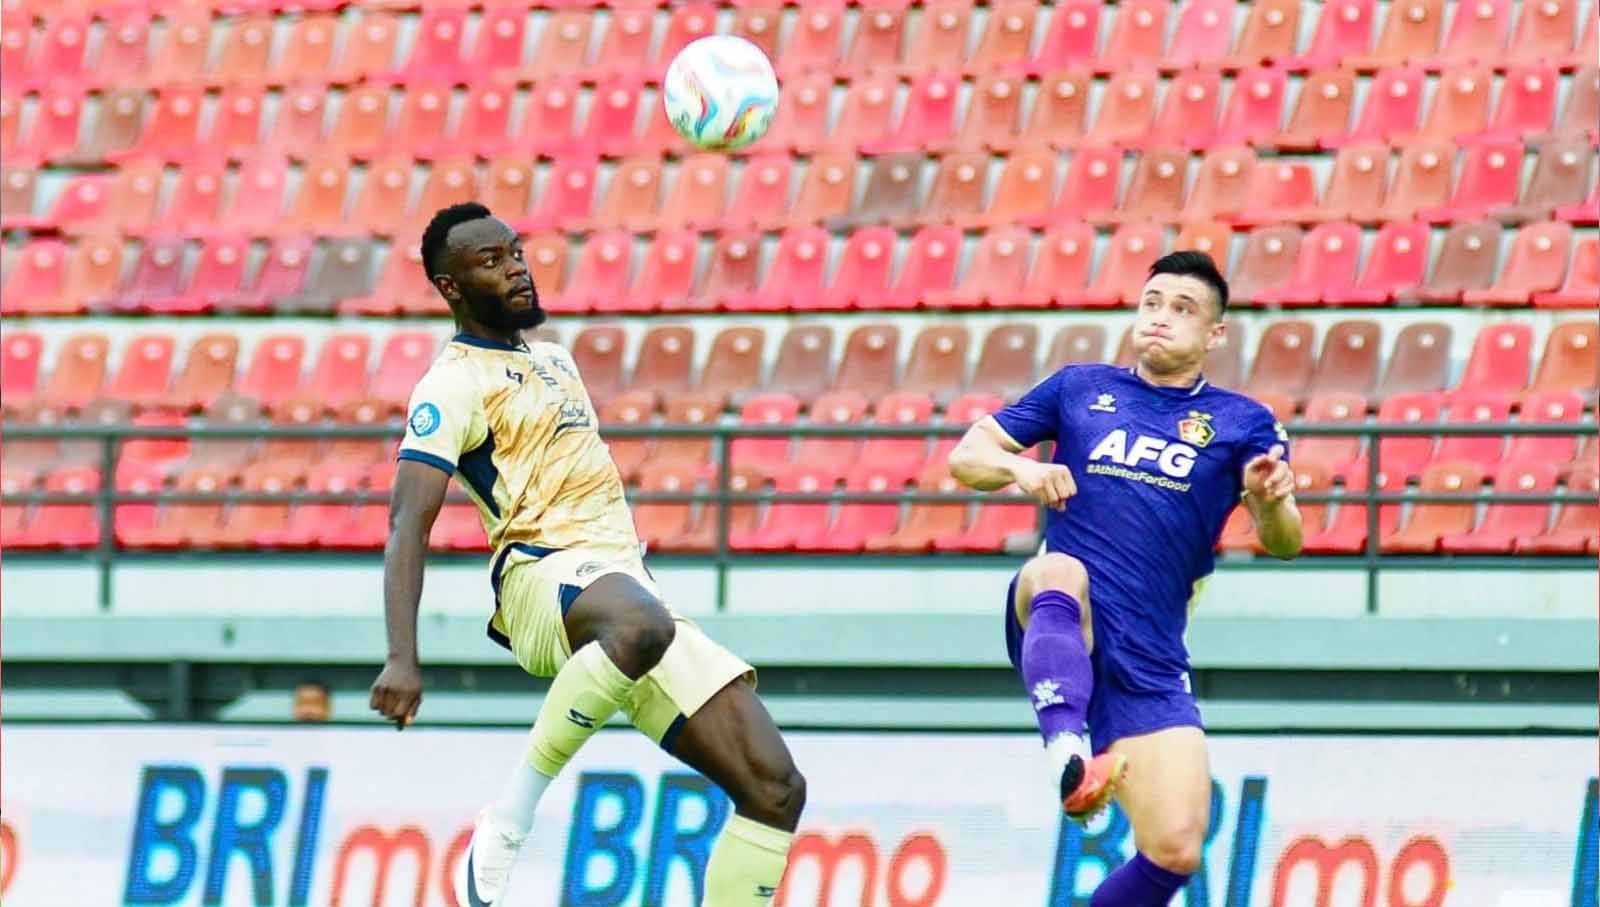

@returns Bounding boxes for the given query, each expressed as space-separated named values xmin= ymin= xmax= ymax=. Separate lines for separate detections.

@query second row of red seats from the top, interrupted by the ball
xmin=12 ymin=64 xmax=1600 ymax=165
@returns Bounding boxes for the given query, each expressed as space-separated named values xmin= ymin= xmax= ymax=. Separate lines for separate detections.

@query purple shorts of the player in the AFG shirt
xmin=1005 ymin=576 xmax=1205 ymax=755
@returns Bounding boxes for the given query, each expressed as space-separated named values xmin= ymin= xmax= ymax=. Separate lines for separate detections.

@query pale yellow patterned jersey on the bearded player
xmin=400 ymin=333 xmax=640 ymax=565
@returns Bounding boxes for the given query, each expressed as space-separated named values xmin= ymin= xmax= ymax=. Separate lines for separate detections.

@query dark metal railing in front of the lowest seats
xmin=0 ymin=422 xmax=1600 ymax=613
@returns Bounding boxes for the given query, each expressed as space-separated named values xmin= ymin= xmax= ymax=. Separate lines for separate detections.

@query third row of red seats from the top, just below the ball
xmin=0 ymin=138 xmax=1600 ymax=235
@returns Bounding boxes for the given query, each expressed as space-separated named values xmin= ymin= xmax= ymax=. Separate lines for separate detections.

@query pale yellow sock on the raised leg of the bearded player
xmin=528 ymin=643 xmax=634 ymax=777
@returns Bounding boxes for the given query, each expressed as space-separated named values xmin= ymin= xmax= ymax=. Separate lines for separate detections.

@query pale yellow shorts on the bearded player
xmin=490 ymin=549 xmax=755 ymax=744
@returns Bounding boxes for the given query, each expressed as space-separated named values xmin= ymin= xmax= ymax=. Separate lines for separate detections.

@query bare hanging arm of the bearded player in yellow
xmin=370 ymin=459 xmax=450 ymax=729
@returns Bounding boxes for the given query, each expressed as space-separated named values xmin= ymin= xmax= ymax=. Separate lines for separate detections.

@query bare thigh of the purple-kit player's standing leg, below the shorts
xmin=1110 ymin=726 xmax=1211 ymax=872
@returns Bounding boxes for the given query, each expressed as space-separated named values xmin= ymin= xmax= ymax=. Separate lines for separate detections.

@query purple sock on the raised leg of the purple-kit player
xmin=1022 ymin=589 xmax=1094 ymax=742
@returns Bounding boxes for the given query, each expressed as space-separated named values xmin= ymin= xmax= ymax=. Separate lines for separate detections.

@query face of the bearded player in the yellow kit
xmin=437 ymin=218 xmax=544 ymax=333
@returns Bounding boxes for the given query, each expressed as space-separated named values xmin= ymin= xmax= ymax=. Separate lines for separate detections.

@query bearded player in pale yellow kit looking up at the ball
xmin=371 ymin=203 xmax=805 ymax=907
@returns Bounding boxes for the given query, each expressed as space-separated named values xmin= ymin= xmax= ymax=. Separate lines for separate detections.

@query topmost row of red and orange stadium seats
xmin=3 ymin=0 xmax=1595 ymax=93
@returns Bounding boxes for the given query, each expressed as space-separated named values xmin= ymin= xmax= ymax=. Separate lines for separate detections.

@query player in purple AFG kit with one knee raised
xmin=949 ymin=251 xmax=1301 ymax=907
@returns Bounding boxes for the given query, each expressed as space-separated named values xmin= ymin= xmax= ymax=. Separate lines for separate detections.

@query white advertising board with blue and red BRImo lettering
xmin=0 ymin=726 xmax=1600 ymax=907
